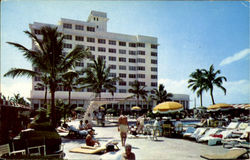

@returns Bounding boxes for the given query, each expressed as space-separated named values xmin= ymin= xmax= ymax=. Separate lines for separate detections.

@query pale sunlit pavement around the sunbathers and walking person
xmin=62 ymin=120 xmax=230 ymax=160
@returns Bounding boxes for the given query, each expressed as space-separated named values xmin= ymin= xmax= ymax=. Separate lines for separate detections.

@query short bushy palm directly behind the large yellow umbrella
xmin=153 ymin=84 xmax=174 ymax=104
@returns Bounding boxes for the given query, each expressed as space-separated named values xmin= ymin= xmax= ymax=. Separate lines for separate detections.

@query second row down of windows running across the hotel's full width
xmin=64 ymin=43 xmax=157 ymax=57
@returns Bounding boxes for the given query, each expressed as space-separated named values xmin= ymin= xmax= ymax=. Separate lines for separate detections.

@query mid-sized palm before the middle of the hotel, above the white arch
xmin=79 ymin=57 xmax=121 ymax=98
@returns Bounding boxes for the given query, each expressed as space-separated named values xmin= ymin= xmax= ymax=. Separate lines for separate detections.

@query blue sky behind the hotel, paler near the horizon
xmin=1 ymin=0 xmax=250 ymax=108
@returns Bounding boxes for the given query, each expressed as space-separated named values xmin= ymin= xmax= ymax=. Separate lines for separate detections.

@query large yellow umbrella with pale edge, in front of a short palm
xmin=153 ymin=102 xmax=183 ymax=113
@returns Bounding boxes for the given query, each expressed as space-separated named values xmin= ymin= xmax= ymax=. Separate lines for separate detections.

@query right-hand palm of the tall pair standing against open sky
xmin=202 ymin=65 xmax=227 ymax=104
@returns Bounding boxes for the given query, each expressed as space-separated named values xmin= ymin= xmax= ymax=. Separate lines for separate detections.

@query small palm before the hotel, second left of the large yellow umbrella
xmin=128 ymin=80 xmax=148 ymax=105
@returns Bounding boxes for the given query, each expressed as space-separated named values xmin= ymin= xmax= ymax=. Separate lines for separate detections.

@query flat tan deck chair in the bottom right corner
xmin=200 ymin=148 xmax=249 ymax=160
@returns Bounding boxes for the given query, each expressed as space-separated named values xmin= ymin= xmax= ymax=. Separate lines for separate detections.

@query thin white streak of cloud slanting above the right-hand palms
xmin=220 ymin=48 xmax=250 ymax=66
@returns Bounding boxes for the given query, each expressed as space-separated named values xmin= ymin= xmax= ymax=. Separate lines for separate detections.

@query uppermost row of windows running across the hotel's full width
xmin=34 ymin=29 xmax=157 ymax=49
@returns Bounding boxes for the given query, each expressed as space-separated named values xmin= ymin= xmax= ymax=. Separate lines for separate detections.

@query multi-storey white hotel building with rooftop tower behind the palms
xmin=30 ymin=11 xmax=189 ymax=110
